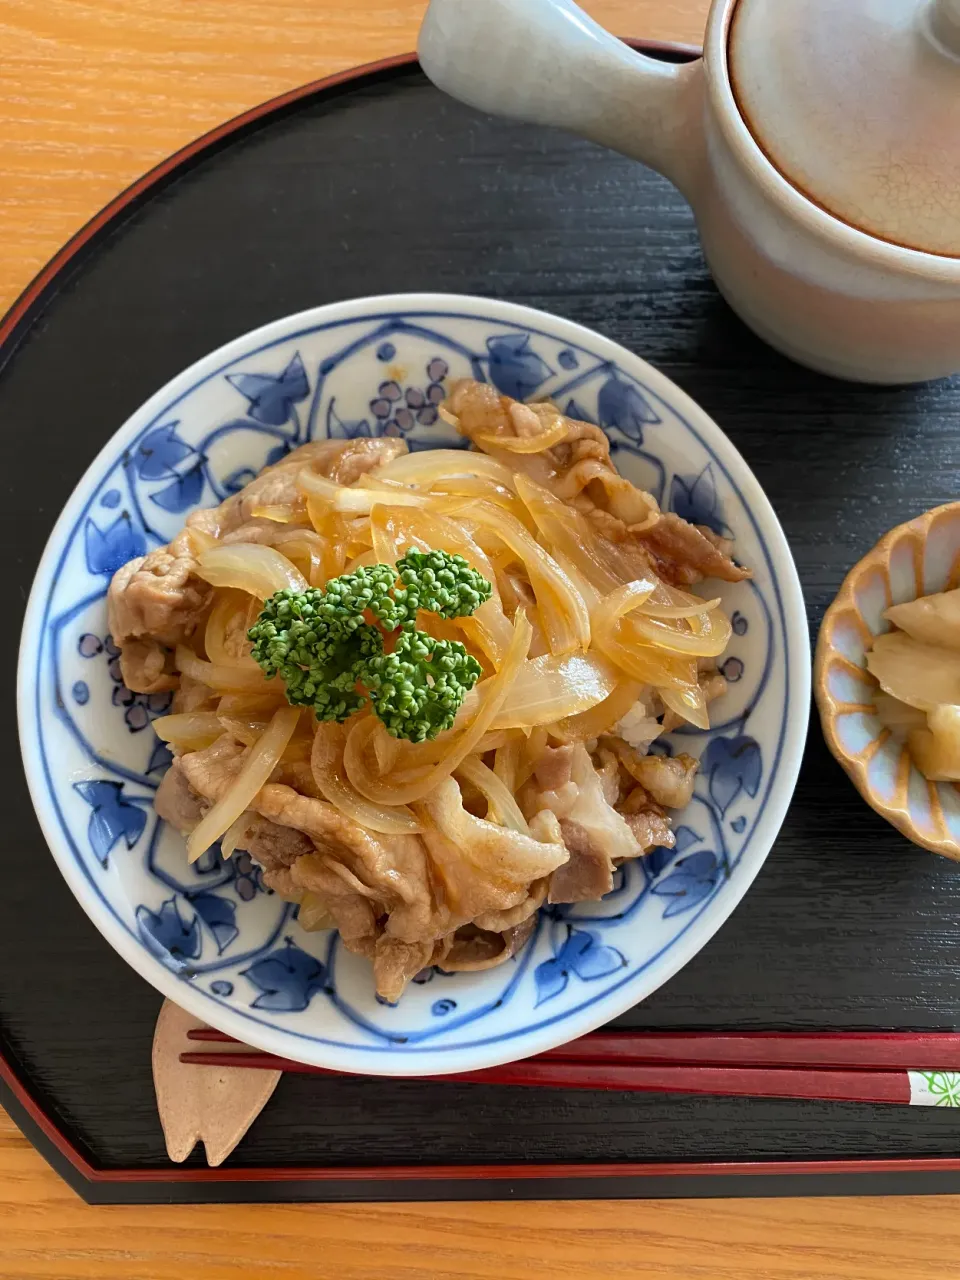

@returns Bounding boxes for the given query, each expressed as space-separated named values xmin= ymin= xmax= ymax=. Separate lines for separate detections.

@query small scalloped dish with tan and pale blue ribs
xmin=814 ymin=502 xmax=960 ymax=860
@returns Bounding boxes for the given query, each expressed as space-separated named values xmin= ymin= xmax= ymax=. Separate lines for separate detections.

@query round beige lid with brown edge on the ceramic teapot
xmin=728 ymin=0 xmax=960 ymax=257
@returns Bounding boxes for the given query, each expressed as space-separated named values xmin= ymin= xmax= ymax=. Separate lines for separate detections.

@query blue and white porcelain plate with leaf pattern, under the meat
xmin=19 ymin=293 xmax=810 ymax=1075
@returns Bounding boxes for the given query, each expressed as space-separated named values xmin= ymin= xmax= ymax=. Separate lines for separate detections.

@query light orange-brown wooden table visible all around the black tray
xmin=0 ymin=0 xmax=960 ymax=1280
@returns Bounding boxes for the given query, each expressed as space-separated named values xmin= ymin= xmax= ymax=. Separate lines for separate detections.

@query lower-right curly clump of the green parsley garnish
xmin=364 ymin=631 xmax=480 ymax=742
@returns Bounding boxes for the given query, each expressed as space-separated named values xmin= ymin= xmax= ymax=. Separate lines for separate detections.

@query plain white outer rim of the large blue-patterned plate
xmin=17 ymin=292 xmax=812 ymax=1076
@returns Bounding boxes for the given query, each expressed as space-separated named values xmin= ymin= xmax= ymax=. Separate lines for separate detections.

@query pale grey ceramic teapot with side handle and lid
xmin=420 ymin=0 xmax=960 ymax=383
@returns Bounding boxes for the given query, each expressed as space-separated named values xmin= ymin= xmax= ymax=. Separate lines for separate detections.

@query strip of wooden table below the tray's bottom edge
xmin=0 ymin=1116 xmax=960 ymax=1280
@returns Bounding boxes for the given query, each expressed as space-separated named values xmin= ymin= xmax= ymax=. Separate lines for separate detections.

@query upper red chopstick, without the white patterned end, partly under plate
xmin=189 ymin=1027 xmax=960 ymax=1071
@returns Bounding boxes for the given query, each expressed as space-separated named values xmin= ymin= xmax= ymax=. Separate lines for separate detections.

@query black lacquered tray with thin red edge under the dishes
xmin=0 ymin=50 xmax=960 ymax=1201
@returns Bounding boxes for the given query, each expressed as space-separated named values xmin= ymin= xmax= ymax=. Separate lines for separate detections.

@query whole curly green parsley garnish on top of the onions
xmin=248 ymin=550 xmax=492 ymax=742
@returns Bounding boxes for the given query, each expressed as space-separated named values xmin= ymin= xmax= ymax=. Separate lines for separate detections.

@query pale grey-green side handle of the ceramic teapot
xmin=419 ymin=0 xmax=703 ymax=195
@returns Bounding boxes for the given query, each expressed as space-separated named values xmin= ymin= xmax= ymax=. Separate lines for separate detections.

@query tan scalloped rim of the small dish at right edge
xmin=813 ymin=502 xmax=960 ymax=861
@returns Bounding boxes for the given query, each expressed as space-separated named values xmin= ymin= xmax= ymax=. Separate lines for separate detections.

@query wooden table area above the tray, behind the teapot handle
xmin=0 ymin=0 xmax=707 ymax=312
